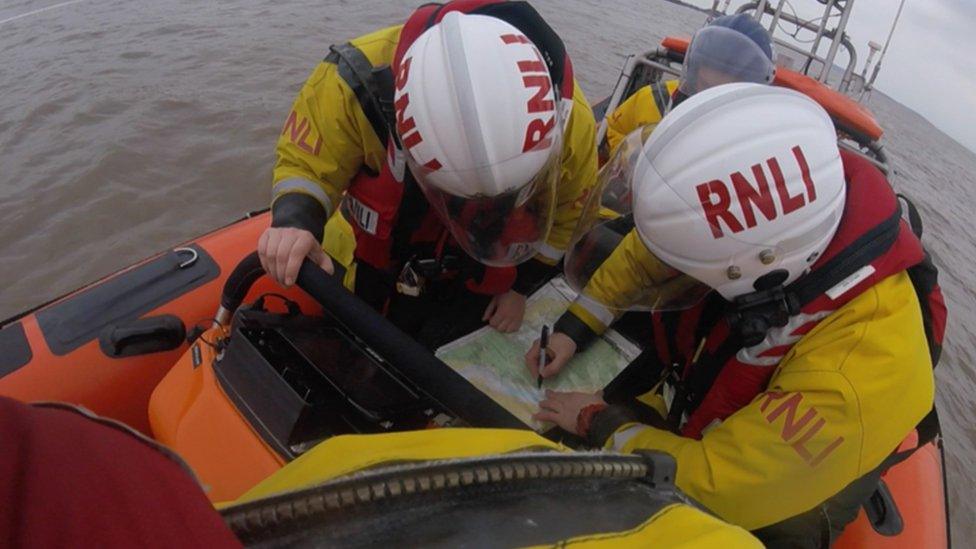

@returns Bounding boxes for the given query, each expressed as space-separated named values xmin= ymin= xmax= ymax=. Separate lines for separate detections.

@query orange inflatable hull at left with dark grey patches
xmin=0 ymin=212 xmax=320 ymax=434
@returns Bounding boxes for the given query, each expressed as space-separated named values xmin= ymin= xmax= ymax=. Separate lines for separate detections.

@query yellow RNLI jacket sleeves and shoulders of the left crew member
xmin=272 ymin=25 xmax=597 ymax=278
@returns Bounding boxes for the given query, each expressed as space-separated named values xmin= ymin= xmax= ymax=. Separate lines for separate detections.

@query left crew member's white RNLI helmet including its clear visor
xmin=394 ymin=12 xmax=564 ymax=265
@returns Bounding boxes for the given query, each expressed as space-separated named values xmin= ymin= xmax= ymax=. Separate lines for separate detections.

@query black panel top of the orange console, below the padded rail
xmin=213 ymin=307 xmax=450 ymax=457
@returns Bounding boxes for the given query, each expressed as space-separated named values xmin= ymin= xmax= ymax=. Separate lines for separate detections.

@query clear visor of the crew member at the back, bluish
xmin=678 ymin=27 xmax=775 ymax=96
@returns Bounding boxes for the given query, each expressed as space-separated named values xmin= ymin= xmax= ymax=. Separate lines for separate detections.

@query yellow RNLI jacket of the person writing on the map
xmin=571 ymin=231 xmax=935 ymax=530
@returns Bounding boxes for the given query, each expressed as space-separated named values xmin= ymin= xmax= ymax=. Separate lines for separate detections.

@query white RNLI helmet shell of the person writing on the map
xmin=634 ymin=84 xmax=846 ymax=300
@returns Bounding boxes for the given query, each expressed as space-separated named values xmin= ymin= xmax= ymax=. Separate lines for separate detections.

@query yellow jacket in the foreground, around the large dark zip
xmin=231 ymin=428 xmax=762 ymax=549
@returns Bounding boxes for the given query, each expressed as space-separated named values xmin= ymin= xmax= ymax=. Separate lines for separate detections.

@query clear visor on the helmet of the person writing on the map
xmin=565 ymin=128 xmax=711 ymax=313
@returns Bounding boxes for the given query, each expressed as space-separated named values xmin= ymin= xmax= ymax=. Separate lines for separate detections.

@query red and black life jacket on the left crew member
xmin=326 ymin=0 xmax=573 ymax=295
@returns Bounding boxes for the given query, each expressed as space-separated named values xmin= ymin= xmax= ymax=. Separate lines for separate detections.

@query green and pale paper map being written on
xmin=435 ymin=278 xmax=640 ymax=432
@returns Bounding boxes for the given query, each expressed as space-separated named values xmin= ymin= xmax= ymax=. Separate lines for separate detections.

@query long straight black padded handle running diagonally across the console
xmin=297 ymin=259 xmax=526 ymax=429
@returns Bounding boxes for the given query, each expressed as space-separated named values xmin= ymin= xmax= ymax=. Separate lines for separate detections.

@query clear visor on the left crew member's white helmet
xmin=407 ymin=131 xmax=562 ymax=267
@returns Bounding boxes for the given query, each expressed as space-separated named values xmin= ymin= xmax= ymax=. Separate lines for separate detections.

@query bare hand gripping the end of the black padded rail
xmin=258 ymin=227 xmax=335 ymax=287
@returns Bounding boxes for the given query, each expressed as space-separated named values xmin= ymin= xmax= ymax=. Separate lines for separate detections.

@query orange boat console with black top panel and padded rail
xmin=149 ymin=253 xmax=527 ymax=500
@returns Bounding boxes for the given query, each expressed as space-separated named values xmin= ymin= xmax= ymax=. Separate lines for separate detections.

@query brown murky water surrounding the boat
xmin=0 ymin=0 xmax=976 ymax=546
